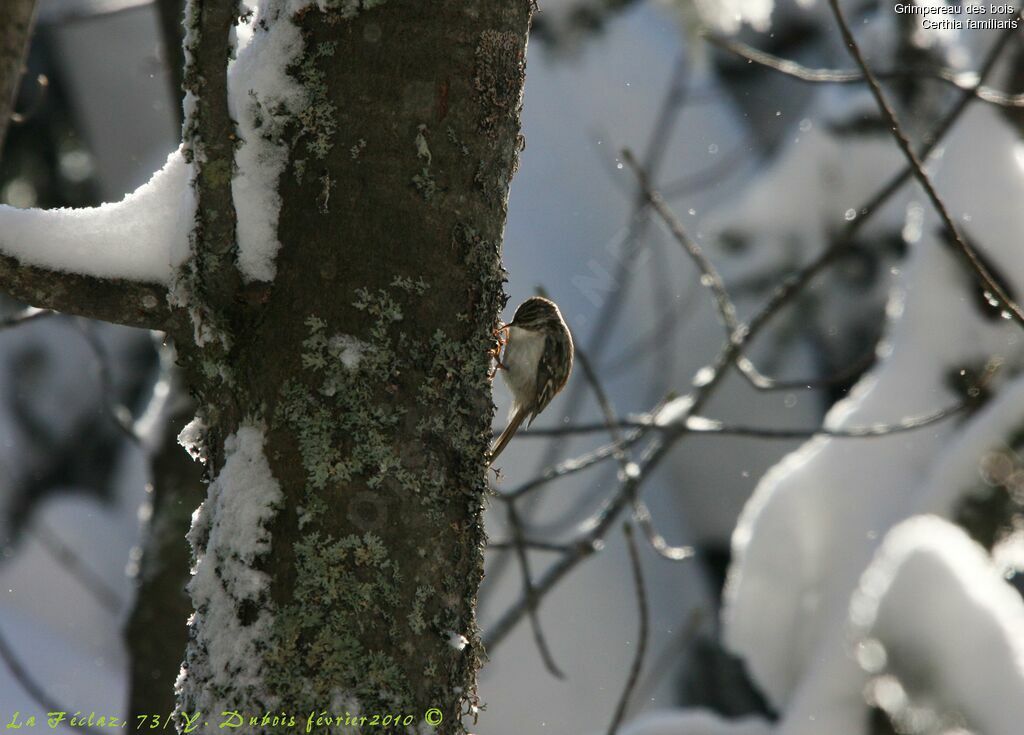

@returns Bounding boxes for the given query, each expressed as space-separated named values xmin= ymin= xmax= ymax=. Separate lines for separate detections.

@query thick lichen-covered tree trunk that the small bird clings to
xmin=168 ymin=0 xmax=530 ymax=733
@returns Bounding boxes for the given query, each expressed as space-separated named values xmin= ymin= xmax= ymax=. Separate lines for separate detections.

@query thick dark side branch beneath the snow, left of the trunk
xmin=0 ymin=254 xmax=171 ymax=330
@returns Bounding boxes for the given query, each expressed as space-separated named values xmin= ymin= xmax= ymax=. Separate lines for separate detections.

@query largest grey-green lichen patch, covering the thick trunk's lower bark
xmin=269 ymin=266 xmax=503 ymax=711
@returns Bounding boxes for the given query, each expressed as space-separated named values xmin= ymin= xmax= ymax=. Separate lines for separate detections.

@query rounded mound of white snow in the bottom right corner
xmin=850 ymin=516 xmax=1024 ymax=735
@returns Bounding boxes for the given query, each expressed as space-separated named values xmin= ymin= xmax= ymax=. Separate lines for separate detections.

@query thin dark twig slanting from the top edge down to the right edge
xmin=828 ymin=0 xmax=1024 ymax=328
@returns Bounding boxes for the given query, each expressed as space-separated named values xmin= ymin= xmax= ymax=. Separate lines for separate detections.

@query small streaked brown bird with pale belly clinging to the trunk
xmin=487 ymin=296 xmax=572 ymax=467
